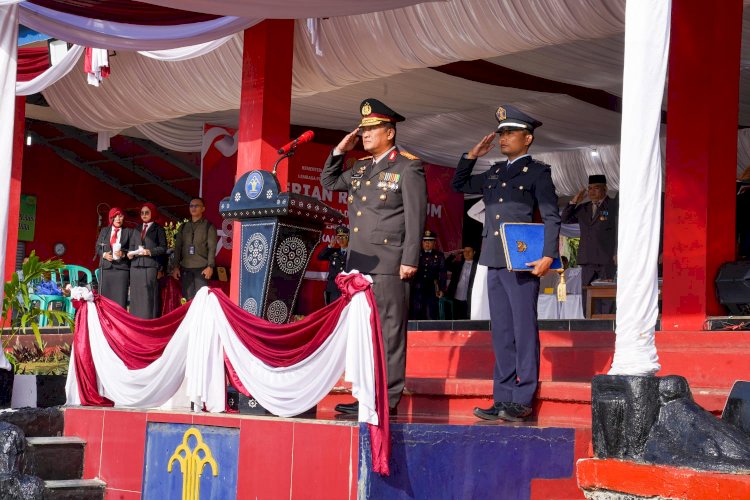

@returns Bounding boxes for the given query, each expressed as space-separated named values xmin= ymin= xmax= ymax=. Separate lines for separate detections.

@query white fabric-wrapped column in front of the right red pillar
xmin=609 ymin=0 xmax=671 ymax=375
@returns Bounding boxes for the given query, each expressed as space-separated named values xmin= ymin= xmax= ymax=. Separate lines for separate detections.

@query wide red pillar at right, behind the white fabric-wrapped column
xmin=661 ymin=0 xmax=742 ymax=330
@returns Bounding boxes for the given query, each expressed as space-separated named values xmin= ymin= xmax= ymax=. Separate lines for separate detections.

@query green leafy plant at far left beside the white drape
xmin=0 ymin=252 xmax=73 ymax=408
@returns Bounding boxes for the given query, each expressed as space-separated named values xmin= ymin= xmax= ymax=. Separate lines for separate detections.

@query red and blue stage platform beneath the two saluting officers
xmin=58 ymin=323 xmax=750 ymax=500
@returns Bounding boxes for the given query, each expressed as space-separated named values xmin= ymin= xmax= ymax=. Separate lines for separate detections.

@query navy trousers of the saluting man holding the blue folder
xmin=487 ymin=268 xmax=539 ymax=406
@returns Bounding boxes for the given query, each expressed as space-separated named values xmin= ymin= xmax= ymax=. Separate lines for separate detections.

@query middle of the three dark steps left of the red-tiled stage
xmin=23 ymin=437 xmax=86 ymax=480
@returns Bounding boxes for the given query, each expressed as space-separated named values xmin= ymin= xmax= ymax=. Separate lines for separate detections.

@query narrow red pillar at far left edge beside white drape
xmin=4 ymin=97 xmax=26 ymax=281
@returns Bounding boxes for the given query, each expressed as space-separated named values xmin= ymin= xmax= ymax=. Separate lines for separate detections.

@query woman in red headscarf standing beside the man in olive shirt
xmin=128 ymin=202 xmax=167 ymax=319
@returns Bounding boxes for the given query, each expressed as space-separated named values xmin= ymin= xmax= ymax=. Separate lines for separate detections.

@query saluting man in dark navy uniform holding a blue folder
xmin=453 ymin=106 xmax=560 ymax=421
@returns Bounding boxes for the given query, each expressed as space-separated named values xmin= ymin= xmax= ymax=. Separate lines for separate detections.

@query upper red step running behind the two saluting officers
xmin=406 ymin=331 xmax=750 ymax=388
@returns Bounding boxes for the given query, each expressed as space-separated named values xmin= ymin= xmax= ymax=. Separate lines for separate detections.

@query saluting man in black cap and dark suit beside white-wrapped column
xmin=562 ymin=174 xmax=618 ymax=313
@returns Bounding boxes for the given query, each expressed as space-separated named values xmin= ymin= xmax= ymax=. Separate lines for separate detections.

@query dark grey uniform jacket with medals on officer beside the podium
xmin=320 ymin=148 xmax=427 ymax=276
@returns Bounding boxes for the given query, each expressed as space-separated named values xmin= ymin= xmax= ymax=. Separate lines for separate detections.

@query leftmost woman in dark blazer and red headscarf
xmin=96 ymin=207 xmax=131 ymax=309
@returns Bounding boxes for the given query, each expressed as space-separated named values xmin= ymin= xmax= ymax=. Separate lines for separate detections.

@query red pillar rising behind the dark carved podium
xmin=230 ymin=19 xmax=294 ymax=301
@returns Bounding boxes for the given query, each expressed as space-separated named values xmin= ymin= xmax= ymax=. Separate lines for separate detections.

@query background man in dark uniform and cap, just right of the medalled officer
xmin=410 ymin=229 xmax=447 ymax=319
